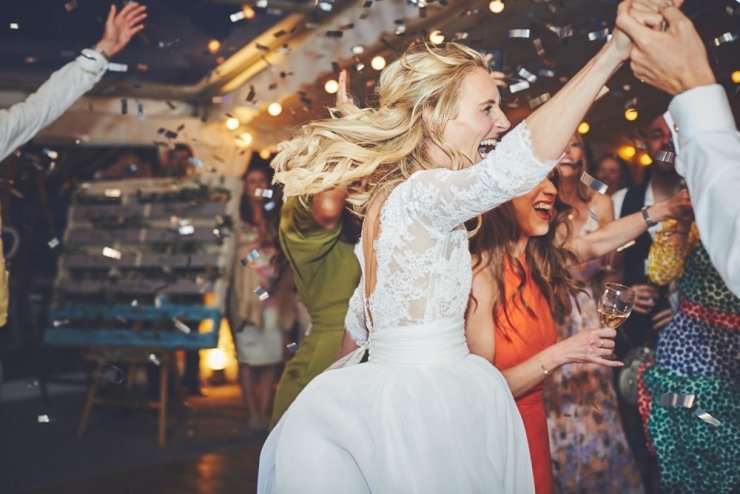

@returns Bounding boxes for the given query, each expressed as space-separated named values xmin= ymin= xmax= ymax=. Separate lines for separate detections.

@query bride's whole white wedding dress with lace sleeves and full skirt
xmin=258 ymin=125 xmax=553 ymax=494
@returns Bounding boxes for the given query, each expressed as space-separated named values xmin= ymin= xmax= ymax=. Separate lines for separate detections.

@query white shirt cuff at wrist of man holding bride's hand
xmin=668 ymin=84 xmax=735 ymax=145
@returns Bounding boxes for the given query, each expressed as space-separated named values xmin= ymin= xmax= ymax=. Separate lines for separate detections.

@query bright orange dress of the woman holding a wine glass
xmin=493 ymin=256 xmax=556 ymax=494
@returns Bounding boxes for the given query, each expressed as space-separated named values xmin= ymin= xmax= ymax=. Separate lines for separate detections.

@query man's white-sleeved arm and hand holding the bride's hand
xmin=617 ymin=0 xmax=740 ymax=296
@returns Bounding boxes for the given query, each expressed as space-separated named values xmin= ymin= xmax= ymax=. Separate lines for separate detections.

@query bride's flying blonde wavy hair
xmin=272 ymin=43 xmax=489 ymax=215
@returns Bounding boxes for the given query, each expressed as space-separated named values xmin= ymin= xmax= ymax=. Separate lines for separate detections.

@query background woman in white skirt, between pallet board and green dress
xmin=229 ymin=165 xmax=296 ymax=430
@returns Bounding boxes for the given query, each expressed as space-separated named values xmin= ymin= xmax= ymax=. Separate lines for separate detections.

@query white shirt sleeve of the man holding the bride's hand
xmin=668 ymin=84 xmax=740 ymax=296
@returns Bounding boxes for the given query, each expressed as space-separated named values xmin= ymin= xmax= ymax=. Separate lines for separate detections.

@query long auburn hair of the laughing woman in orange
xmin=470 ymin=173 xmax=582 ymax=337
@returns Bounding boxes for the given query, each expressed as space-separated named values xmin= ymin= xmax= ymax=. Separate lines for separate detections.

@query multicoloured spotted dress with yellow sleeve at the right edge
xmin=638 ymin=213 xmax=740 ymax=494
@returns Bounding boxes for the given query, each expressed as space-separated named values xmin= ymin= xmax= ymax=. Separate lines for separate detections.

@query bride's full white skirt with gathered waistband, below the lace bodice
xmin=258 ymin=325 xmax=534 ymax=494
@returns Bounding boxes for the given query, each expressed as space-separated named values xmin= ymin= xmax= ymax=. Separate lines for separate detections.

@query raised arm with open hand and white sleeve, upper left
xmin=0 ymin=2 xmax=146 ymax=160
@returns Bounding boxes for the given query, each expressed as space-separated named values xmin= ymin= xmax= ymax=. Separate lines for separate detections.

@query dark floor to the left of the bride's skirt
xmin=0 ymin=385 xmax=266 ymax=494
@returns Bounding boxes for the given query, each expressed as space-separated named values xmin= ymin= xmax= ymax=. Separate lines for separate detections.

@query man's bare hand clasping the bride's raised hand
xmin=617 ymin=0 xmax=716 ymax=95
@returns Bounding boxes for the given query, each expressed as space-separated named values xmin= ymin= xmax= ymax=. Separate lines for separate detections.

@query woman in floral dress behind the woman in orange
xmin=544 ymin=134 xmax=642 ymax=493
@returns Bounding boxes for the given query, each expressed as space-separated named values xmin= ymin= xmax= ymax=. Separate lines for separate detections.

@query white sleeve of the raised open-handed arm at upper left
xmin=0 ymin=49 xmax=108 ymax=160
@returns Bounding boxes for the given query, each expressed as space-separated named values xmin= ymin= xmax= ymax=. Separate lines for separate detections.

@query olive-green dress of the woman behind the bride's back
xmin=270 ymin=197 xmax=360 ymax=427
